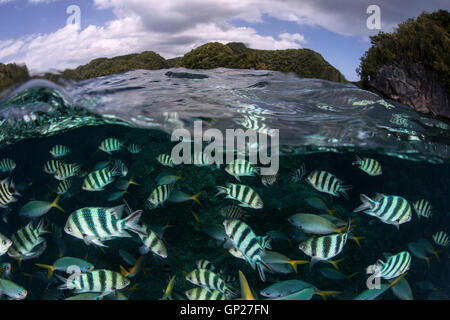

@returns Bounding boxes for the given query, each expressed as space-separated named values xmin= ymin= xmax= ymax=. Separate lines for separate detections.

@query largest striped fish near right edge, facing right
xmin=353 ymin=193 xmax=412 ymax=229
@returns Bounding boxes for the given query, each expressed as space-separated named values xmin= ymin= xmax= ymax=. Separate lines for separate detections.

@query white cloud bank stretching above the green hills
xmin=0 ymin=0 xmax=448 ymax=72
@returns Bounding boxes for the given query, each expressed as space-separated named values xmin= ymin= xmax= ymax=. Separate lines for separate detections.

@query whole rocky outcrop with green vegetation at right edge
xmin=358 ymin=10 xmax=450 ymax=118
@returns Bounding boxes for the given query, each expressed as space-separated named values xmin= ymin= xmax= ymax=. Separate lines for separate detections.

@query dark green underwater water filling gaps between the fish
xmin=0 ymin=125 xmax=450 ymax=299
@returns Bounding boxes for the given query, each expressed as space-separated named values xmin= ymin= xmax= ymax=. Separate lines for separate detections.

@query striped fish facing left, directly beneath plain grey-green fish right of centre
xmin=298 ymin=221 xmax=350 ymax=269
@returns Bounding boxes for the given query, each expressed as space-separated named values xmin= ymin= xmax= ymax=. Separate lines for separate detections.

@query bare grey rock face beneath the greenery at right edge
xmin=368 ymin=63 xmax=450 ymax=118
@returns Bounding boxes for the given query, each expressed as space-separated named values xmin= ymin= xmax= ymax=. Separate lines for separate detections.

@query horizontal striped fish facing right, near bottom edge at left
xmin=57 ymin=269 xmax=130 ymax=295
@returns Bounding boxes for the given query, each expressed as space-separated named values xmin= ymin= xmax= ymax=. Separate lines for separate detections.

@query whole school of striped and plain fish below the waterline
xmin=0 ymin=131 xmax=450 ymax=300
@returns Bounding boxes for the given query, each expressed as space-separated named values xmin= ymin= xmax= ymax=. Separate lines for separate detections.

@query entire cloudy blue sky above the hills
xmin=0 ymin=0 xmax=450 ymax=81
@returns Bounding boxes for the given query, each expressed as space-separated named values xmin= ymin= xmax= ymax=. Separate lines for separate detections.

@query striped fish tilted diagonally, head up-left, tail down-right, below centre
xmin=223 ymin=219 xmax=272 ymax=281
